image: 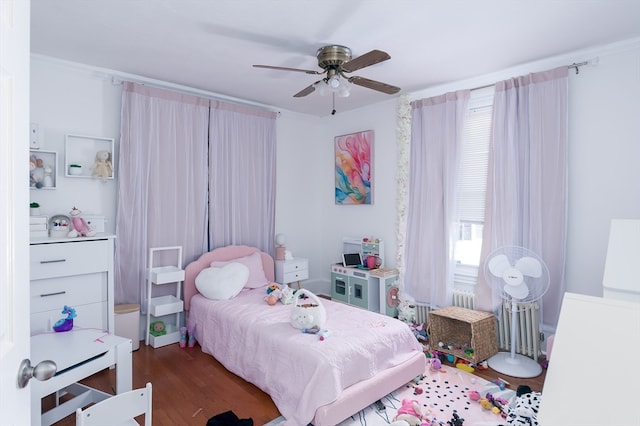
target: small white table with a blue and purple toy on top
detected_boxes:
[30,329,132,425]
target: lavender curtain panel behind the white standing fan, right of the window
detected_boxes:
[477,67,568,324]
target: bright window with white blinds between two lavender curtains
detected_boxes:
[454,87,493,285]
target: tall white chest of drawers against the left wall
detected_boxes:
[30,235,115,335]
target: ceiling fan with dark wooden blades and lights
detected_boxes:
[254,45,400,98]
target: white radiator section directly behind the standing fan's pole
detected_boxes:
[498,302,540,361]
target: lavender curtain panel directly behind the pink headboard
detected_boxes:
[209,101,277,254]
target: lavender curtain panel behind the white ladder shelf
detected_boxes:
[115,82,209,306]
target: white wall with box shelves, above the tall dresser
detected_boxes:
[30,56,121,233]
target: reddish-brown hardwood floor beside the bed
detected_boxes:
[48,342,545,426]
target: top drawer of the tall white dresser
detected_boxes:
[30,240,113,280]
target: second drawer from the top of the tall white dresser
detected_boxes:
[31,273,107,313]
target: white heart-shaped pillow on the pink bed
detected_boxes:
[196,262,249,300]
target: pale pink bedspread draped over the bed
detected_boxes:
[189,288,422,426]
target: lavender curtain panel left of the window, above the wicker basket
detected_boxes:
[402,90,470,306]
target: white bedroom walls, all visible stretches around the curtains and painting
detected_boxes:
[31,40,640,302]
